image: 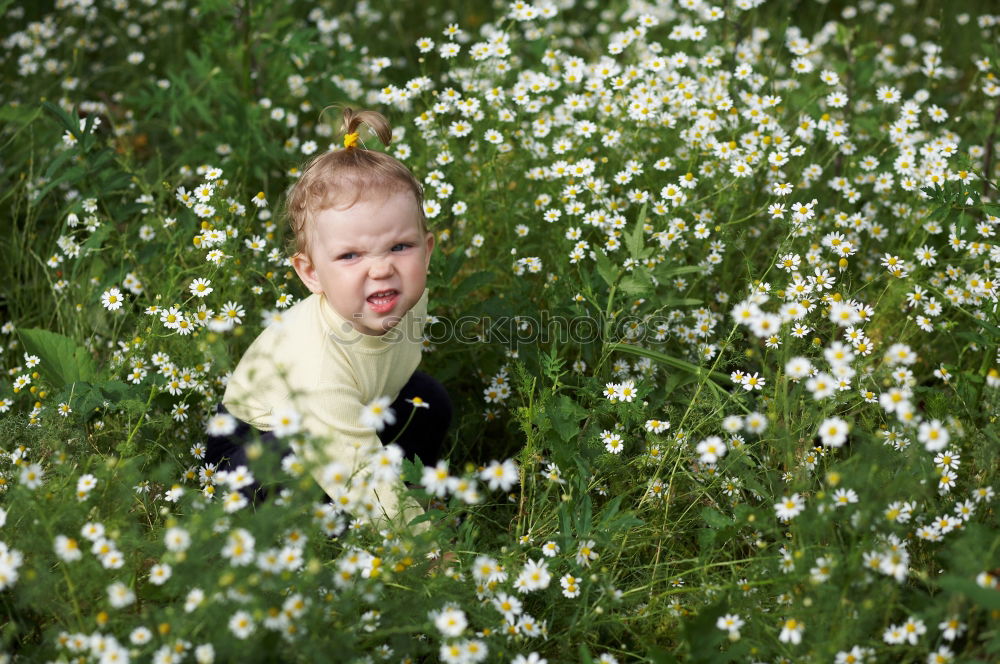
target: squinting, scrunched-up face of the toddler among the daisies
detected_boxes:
[292,191,434,335]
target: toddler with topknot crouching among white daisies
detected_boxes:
[206,108,451,526]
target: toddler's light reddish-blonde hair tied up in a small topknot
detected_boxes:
[285,107,427,253]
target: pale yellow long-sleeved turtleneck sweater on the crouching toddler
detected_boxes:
[223,290,427,530]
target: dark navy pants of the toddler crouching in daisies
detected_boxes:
[205,371,452,502]
